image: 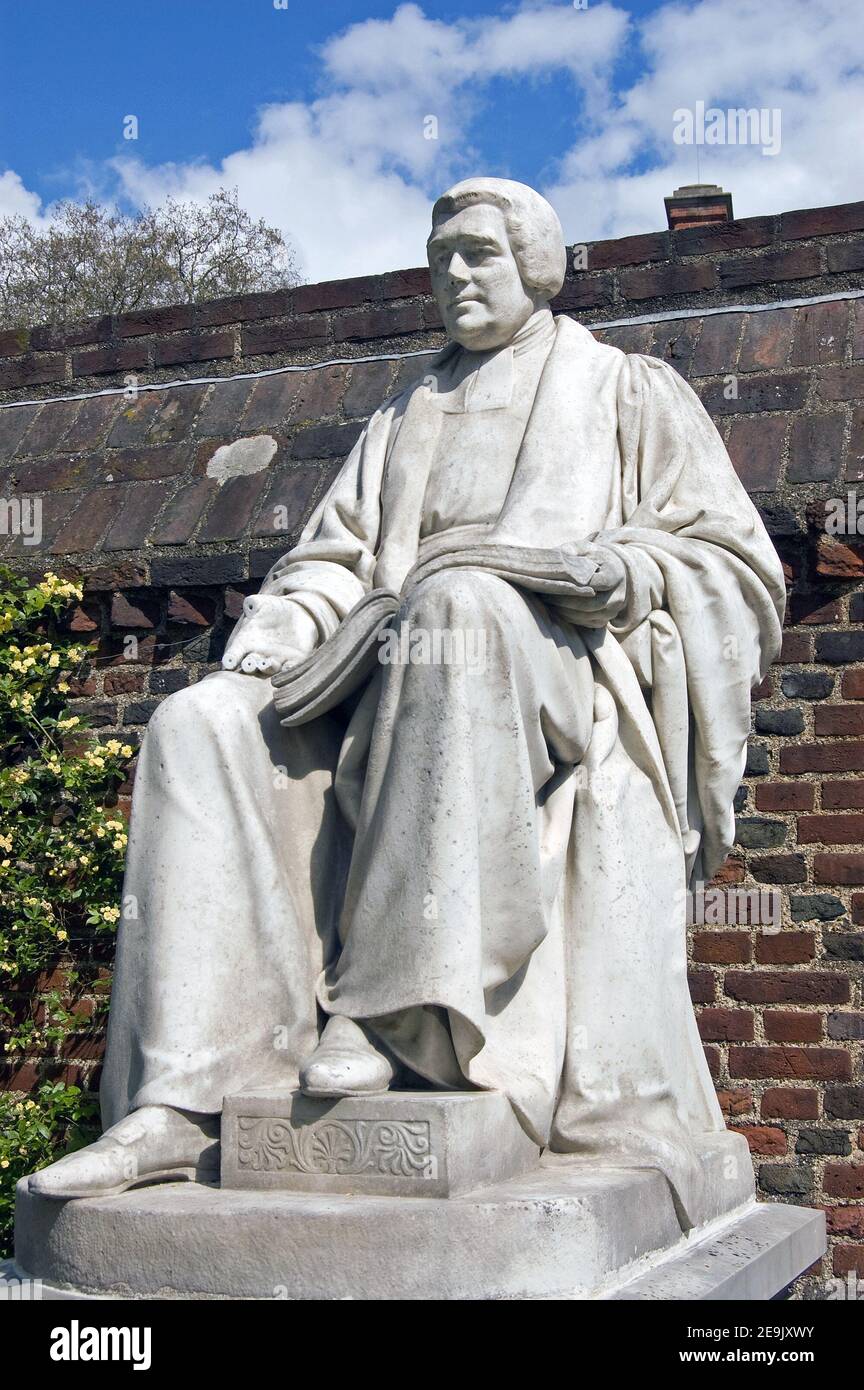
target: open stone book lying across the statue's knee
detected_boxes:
[272,538,597,727]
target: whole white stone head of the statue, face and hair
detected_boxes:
[426,178,567,352]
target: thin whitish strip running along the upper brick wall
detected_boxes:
[0,289,864,410]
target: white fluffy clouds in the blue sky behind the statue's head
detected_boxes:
[0,0,864,279]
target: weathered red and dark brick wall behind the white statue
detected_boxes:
[0,195,864,1277]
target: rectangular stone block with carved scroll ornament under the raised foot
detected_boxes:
[222,1090,539,1197]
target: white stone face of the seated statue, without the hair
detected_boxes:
[426,203,539,352]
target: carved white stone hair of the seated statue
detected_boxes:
[432,178,567,299]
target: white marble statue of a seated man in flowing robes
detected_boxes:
[31,178,783,1213]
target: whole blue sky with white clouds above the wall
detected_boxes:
[0,0,864,279]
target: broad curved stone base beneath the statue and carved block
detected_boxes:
[15,1165,825,1300]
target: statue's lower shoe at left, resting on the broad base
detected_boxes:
[28,1105,219,1201]
